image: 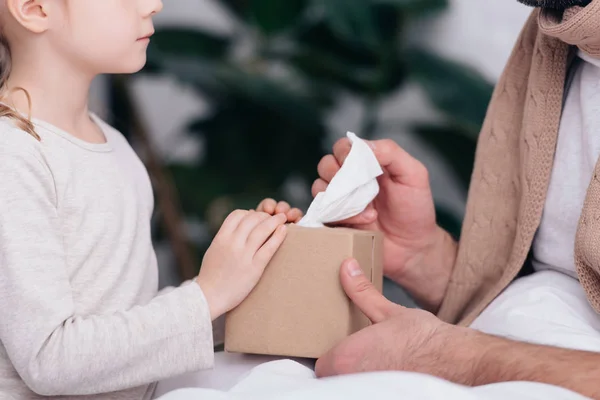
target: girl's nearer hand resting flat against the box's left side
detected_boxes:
[196,210,287,320]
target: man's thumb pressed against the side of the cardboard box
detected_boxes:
[340,258,402,323]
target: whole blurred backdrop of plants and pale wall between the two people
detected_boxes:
[92,0,530,340]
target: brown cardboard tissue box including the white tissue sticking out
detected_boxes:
[225,132,383,358]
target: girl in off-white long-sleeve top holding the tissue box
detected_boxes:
[0,0,300,399]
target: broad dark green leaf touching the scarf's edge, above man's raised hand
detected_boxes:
[406,49,493,135]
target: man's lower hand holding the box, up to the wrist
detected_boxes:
[316,260,459,377]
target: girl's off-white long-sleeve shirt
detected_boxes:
[0,116,214,400]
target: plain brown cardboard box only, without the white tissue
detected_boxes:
[225,225,383,358]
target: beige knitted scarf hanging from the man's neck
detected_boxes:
[439,0,600,325]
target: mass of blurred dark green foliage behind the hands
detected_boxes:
[108,0,492,272]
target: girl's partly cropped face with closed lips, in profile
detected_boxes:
[45,0,162,74]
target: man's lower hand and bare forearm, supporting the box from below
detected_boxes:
[316,260,600,399]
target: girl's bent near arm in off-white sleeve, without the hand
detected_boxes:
[0,149,214,395]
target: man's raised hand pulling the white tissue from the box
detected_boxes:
[312,138,457,311]
